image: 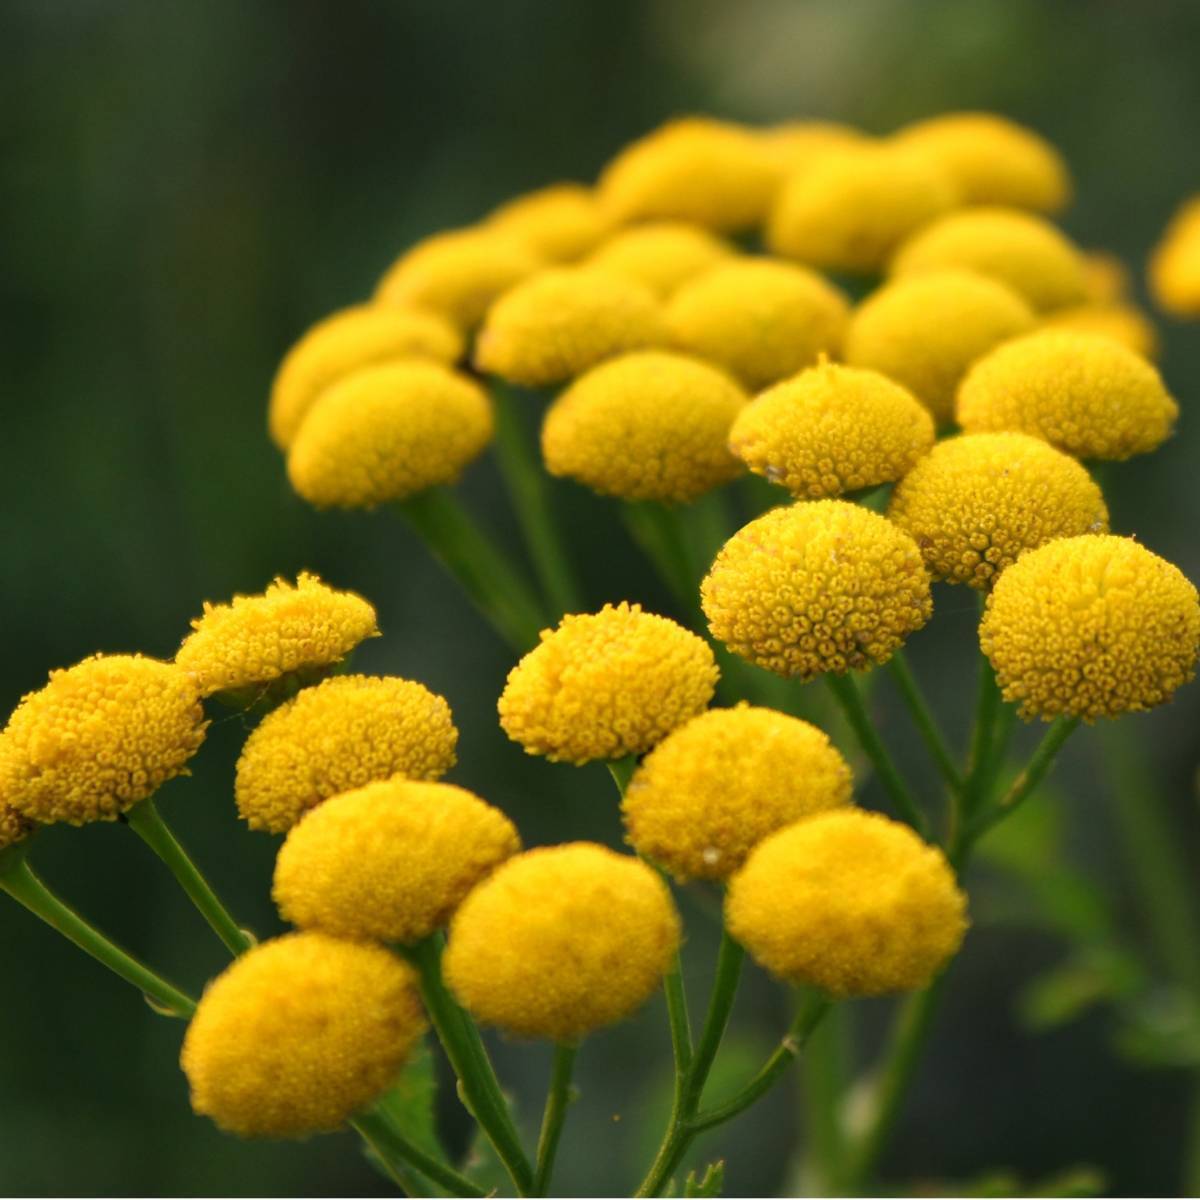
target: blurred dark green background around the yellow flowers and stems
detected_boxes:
[0,0,1200,1195]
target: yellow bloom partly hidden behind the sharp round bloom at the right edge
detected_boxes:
[888,433,1109,588]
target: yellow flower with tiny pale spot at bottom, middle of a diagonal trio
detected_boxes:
[622,703,851,881]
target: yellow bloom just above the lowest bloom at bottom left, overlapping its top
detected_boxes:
[272,779,521,944]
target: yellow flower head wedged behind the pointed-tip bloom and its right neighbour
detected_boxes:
[845,270,1034,425]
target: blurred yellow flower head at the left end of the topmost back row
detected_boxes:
[599,116,780,233]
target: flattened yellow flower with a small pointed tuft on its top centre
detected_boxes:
[730,362,934,499]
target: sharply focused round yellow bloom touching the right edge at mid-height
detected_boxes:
[979,534,1200,721]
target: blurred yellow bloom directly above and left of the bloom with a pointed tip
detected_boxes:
[666,258,850,390]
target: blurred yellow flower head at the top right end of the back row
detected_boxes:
[895,113,1072,212]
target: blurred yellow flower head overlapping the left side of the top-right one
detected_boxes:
[767,143,958,274]
